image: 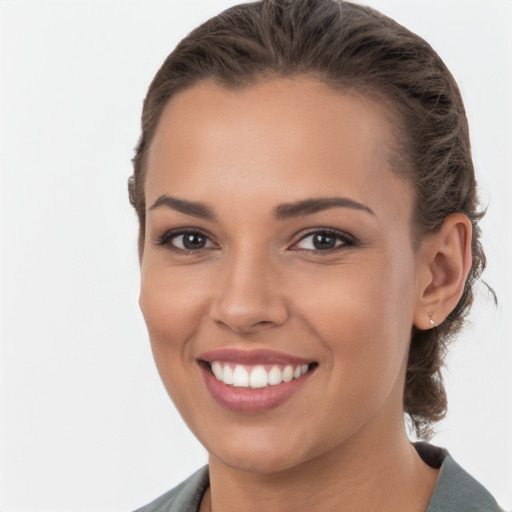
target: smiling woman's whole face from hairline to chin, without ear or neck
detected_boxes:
[140,78,426,472]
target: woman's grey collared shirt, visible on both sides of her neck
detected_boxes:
[136,443,503,512]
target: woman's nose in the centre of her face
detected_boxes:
[210,249,288,334]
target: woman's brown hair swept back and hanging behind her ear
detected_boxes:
[129,0,485,438]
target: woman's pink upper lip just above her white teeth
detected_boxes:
[198,348,314,365]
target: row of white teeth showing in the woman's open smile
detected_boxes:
[203,361,318,389]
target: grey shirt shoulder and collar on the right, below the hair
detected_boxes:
[415,443,502,512]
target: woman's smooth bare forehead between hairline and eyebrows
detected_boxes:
[146,78,408,220]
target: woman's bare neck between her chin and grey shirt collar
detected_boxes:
[205,428,438,512]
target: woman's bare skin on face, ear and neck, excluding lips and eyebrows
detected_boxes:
[140,78,471,512]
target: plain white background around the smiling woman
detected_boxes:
[0,0,512,512]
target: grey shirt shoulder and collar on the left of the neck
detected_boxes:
[135,466,209,512]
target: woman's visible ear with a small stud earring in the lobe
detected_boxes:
[414,213,472,329]
